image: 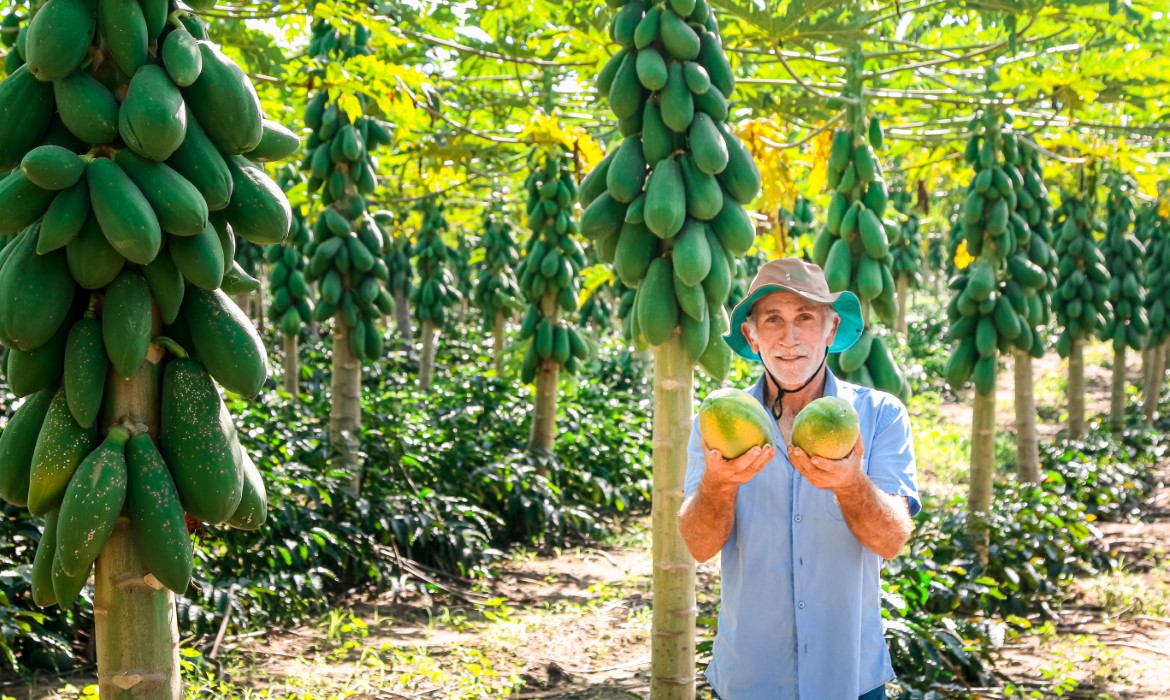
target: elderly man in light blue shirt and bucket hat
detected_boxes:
[679,259,920,700]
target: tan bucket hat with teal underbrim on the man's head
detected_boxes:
[723,258,866,362]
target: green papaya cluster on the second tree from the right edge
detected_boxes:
[1101,170,1150,351]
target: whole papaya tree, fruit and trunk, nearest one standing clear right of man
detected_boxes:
[944,105,1046,543]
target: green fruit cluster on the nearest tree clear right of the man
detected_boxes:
[944,110,1054,394]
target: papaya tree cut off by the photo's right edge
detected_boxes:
[1140,183,1170,420]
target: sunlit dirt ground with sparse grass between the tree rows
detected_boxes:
[9,344,1170,700]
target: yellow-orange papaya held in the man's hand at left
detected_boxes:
[697,388,776,459]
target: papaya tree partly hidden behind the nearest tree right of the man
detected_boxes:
[1007,146,1057,483]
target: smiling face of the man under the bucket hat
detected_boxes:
[741,290,841,389]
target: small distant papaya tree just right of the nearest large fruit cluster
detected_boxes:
[264,174,312,402]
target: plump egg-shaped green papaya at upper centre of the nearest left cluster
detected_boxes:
[118,64,187,160]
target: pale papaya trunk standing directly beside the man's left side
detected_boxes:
[651,336,697,700]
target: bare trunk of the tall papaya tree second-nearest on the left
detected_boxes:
[329,315,362,496]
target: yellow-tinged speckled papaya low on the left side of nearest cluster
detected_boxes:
[28,387,97,516]
